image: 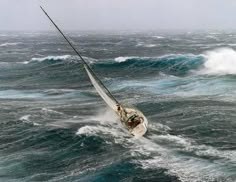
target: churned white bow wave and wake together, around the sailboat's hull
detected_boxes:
[76,118,235,182]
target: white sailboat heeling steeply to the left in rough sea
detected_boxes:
[40,6,148,138]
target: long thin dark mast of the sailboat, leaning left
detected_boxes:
[40,6,120,105]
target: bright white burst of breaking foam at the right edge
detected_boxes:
[200,48,236,75]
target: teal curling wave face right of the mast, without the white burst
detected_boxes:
[111,54,204,76]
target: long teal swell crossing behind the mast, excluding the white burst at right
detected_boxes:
[25,54,204,76]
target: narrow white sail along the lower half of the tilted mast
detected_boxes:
[84,65,117,111]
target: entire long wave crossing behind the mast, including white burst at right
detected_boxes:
[20,48,236,77]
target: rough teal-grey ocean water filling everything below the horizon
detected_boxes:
[0,31,236,182]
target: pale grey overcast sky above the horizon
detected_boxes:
[0,0,236,31]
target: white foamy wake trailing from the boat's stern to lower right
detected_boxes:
[131,135,235,182]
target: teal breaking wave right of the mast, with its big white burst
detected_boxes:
[115,48,236,76]
